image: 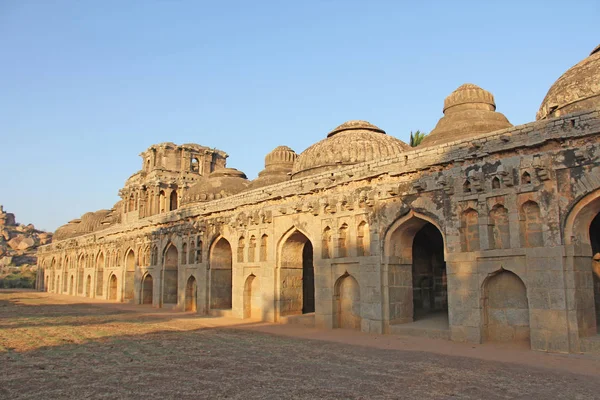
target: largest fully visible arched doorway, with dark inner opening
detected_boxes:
[386,212,448,329]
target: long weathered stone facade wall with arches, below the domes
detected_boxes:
[39,110,600,352]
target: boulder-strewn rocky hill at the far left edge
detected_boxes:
[0,206,52,288]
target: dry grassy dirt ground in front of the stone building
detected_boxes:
[0,291,600,400]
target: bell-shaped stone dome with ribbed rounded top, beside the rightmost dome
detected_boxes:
[420,83,512,146]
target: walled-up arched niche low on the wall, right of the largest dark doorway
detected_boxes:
[483,270,529,343]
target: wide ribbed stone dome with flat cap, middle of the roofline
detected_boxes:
[292,121,410,178]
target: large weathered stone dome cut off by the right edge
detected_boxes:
[536,46,600,120]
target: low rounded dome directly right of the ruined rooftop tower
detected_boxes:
[181,168,248,204]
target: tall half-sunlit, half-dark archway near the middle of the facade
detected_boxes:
[279,231,315,316]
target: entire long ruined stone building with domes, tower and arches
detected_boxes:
[38,48,600,352]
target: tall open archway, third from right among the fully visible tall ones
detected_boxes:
[209,237,233,309]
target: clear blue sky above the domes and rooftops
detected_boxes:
[0,0,600,230]
